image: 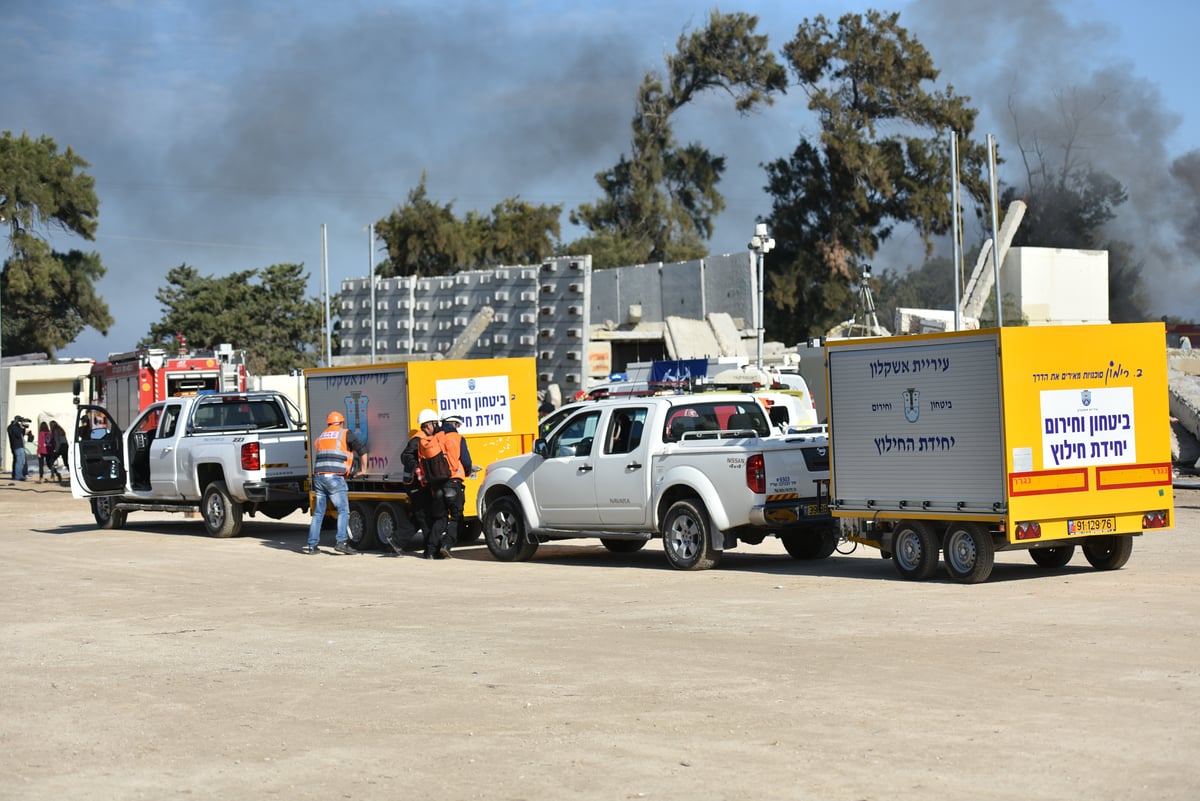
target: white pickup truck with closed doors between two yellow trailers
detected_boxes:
[476,393,839,570]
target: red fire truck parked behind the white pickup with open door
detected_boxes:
[86,344,247,429]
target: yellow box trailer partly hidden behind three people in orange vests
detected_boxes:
[304,357,538,549]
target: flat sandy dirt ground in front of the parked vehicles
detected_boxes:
[0,480,1200,801]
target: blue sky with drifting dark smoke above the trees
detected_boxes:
[7,0,1200,359]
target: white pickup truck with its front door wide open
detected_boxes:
[70,391,308,537]
